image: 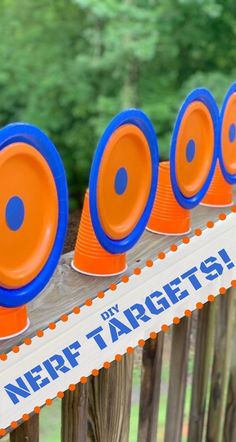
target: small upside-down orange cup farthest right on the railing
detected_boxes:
[201,163,233,207]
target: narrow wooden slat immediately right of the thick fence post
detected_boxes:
[138,333,164,442]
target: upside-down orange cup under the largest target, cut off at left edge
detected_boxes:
[0,305,29,340]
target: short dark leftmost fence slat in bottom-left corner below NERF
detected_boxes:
[10,414,39,442]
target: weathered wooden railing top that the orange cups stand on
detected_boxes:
[0,206,230,353]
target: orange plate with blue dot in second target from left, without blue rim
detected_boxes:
[97,124,152,239]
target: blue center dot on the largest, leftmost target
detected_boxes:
[6,196,25,231]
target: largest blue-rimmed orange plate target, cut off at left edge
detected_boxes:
[0,123,68,307]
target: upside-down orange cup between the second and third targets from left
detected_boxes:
[146,161,190,235]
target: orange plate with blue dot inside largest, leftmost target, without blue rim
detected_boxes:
[0,142,58,289]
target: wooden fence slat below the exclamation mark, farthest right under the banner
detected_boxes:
[206,289,234,442]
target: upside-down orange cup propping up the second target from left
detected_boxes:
[72,191,127,276]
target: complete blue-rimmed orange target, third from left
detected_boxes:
[170,89,219,209]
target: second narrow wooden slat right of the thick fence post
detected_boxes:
[165,317,191,442]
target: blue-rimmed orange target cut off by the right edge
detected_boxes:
[219,83,236,184]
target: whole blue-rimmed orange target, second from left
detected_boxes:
[89,109,158,253]
